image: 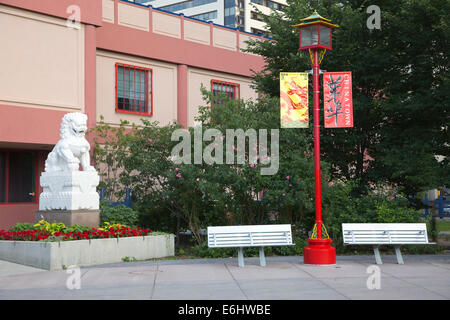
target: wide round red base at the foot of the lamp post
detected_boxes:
[303,239,336,265]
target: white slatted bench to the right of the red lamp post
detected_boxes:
[342,223,434,264]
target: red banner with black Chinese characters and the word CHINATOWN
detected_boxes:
[323,72,353,128]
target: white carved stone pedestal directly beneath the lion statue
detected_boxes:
[39,171,100,211]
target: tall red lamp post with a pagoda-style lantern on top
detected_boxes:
[293,11,338,265]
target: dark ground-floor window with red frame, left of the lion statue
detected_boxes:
[0,151,37,204]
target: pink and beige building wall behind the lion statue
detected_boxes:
[0,0,264,229]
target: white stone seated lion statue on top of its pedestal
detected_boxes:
[45,112,96,172]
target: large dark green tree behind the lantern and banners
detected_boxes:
[244,0,450,194]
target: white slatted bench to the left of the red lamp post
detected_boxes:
[208,224,294,267]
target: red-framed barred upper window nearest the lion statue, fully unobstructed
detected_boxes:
[116,63,153,116]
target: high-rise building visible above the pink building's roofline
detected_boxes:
[134,0,287,35]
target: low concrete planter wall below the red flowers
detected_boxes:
[0,234,175,270]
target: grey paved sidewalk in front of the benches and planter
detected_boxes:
[0,254,450,300]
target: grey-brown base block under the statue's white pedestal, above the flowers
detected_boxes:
[34,210,100,228]
